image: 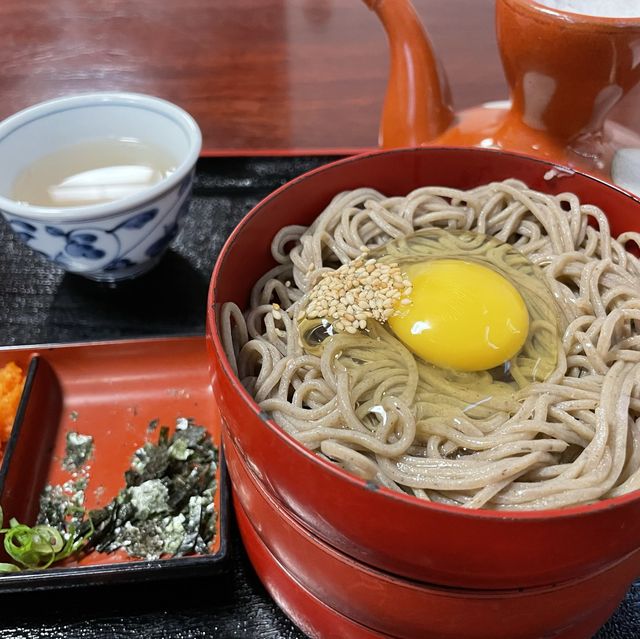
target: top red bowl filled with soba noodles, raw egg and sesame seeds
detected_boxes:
[207,147,640,600]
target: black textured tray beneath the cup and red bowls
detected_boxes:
[0,157,640,639]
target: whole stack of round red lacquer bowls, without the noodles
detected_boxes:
[207,148,640,639]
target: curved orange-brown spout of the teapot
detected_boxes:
[364,0,453,148]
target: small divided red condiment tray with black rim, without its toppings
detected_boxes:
[0,337,229,591]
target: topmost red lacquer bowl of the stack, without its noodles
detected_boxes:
[207,148,640,589]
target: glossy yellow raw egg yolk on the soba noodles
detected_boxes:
[389,259,529,371]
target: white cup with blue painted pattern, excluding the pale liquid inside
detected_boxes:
[0,93,202,282]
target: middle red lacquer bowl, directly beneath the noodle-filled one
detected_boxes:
[223,429,640,639]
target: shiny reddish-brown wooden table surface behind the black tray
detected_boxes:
[0,0,640,152]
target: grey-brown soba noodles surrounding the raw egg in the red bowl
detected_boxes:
[221,180,640,510]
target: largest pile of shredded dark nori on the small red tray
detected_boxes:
[80,418,218,559]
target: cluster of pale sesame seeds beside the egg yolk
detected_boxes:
[298,256,412,333]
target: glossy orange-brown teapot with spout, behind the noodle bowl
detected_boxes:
[365,0,640,194]
